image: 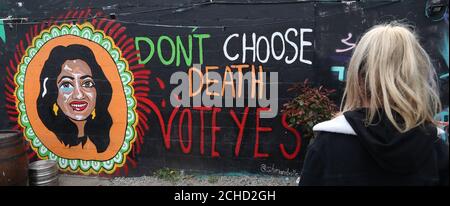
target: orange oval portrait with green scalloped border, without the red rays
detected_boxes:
[15,24,137,172]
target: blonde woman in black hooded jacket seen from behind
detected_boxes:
[300,23,449,186]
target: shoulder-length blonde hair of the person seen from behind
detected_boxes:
[341,22,441,133]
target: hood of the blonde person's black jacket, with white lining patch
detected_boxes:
[313,109,438,174]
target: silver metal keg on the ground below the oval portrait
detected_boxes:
[28,160,59,186]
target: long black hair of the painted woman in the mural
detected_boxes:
[37,44,112,153]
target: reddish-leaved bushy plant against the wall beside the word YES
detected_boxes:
[281,79,338,138]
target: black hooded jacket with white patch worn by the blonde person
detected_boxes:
[299,109,449,186]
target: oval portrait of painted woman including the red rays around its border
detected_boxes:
[5,10,155,174]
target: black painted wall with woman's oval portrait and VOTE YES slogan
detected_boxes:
[0,0,448,176]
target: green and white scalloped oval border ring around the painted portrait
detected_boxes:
[14,23,138,174]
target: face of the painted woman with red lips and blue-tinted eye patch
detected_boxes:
[56,59,97,121]
